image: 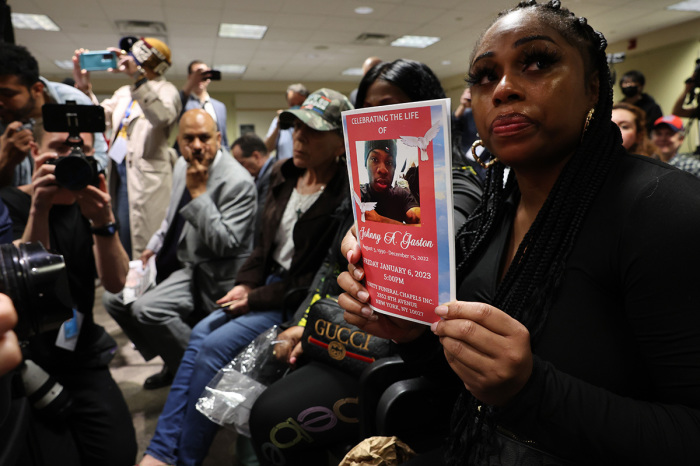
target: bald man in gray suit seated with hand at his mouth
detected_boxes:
[103,109,257,389]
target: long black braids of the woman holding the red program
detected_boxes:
[447,0,624,464]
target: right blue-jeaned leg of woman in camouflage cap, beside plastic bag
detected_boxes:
[177,311,282,466]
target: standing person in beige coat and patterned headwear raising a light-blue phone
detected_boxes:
[73,37,182,258]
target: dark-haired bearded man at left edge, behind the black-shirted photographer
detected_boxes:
[0,43,107,192]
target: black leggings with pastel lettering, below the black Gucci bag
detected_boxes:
[250,362,359,466]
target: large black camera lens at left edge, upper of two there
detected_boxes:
[0,243,73,339]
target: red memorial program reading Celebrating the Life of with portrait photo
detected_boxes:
[343,99,455,324]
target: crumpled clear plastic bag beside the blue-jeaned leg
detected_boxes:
[197,325,288,437]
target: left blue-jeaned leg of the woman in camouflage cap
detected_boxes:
[146,311,231,464]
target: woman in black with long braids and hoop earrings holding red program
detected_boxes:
[339,1,700,465]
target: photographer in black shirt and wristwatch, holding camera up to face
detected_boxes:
[0,124,137,466]
